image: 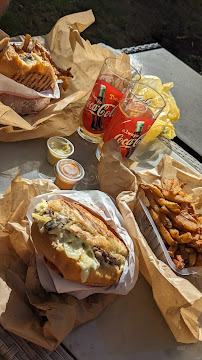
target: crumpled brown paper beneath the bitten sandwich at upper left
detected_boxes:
[0,10,129,142]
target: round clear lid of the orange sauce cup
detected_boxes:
[55,159,85,182]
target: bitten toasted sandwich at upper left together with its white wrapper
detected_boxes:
[0,34,72,114]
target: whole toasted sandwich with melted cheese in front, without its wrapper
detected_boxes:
[31,199,128,286]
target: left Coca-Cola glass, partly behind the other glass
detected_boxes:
[77,57,140,143]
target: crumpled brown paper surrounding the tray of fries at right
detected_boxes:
[98,143,202,343]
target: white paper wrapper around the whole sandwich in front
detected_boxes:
[27,190,138,299]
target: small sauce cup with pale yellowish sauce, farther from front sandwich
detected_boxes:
[47,136,74,165]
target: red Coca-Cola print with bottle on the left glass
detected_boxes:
[83,79,123,134]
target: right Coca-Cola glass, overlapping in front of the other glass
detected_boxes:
[96,81,166,160]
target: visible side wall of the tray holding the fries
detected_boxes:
[134,193,202,276]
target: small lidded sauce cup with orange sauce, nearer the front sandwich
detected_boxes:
[55,159,85,190]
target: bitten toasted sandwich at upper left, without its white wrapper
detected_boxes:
[0,34,72,92]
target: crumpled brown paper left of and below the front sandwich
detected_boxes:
[0,175,116,350]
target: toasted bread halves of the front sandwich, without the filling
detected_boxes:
[31,200,128,286]
